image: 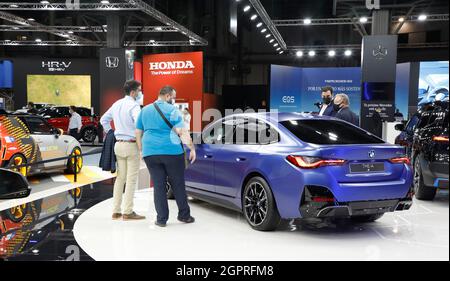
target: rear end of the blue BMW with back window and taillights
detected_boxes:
[282,119,413,218]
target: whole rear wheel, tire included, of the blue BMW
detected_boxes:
[242,177,281,231]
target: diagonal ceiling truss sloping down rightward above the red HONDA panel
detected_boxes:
[125,0,208,46]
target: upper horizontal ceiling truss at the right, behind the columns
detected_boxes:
[273,14,449,26]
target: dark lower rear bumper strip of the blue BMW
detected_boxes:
[300,199,412,218]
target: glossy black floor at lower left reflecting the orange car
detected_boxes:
[0,181,112,261]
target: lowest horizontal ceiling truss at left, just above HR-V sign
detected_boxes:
[0,40,203,47]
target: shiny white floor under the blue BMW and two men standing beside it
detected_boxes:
[74,190,449,261]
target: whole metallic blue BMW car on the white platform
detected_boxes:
[181,113,413,231]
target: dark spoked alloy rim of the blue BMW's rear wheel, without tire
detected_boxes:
[244,182,269,226]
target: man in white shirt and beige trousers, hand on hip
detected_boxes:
[100,80,145,221]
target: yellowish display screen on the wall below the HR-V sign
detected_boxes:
[27,75,91,108]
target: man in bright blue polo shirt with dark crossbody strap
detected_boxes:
[136,86,196,227]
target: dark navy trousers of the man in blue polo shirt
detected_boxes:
[144,154,191,223]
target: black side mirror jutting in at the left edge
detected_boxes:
[0,169,31,200]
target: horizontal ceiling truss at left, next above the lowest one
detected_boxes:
[0,25,178,33]
